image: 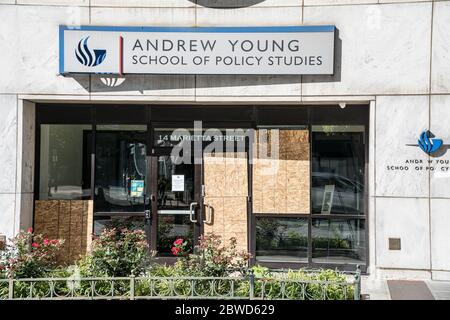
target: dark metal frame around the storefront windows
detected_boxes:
[33,103,372,272]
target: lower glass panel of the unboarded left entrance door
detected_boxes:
[156,214,194,255]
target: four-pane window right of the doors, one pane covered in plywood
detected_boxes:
[253,125,366,264]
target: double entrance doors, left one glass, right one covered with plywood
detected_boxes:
[151,123,248,257]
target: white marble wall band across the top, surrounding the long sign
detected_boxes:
[0,0,440,101]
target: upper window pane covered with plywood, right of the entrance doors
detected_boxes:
[253,127,311,214]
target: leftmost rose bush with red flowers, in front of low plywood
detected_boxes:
[0,228,64,278]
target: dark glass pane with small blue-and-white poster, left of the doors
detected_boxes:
[94,125,150,240]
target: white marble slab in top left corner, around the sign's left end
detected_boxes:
[0,5,89,95]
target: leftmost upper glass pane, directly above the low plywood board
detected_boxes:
[39,124,92,200]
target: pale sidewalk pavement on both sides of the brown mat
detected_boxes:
[361,276,450,300]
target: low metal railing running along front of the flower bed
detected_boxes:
[0,269,361,300]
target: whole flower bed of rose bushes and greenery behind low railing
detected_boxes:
[0,228,360,300]
